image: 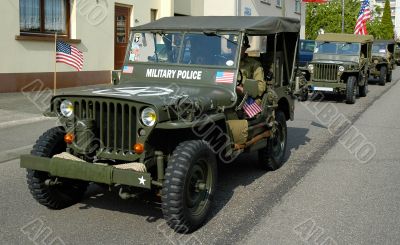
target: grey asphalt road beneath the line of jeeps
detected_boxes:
[0,72,400,244]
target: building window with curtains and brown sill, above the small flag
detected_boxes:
[19,0,69,36]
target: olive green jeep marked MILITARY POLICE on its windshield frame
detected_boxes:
[21,17,300,232]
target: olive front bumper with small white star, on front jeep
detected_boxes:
[20,155,152,189]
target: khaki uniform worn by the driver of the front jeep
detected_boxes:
[239,56,266,96]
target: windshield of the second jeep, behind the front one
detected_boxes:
[314,42,360,56]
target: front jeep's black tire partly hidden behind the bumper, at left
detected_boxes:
[27,127,87,209]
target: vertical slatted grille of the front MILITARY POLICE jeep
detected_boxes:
[73,99,136,153]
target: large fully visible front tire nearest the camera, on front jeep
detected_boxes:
[161,140,217,233]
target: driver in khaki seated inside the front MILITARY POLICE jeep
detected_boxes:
[237,36,266,105]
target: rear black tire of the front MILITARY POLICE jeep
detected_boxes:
[258,111,287,171]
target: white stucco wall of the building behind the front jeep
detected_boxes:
[0,0,174,73]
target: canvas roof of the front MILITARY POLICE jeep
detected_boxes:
[133,16,300,35]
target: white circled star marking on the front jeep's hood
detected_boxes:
[92,87,174,97]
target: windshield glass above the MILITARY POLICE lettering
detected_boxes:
[127,32,238,67]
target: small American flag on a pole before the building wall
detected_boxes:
[56,41,83,71]
